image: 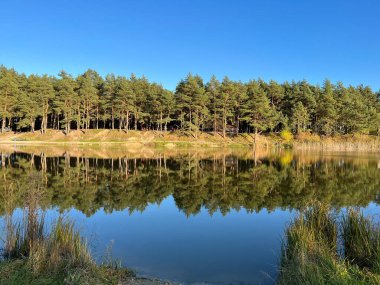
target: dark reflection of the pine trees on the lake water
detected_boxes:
[0,154,380,215]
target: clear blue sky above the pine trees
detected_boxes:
[0,0,380,90]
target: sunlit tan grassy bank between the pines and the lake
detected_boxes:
[0,130,380,152]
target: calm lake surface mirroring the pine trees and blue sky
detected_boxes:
[0,146,380,285]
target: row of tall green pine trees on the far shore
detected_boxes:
[0,66,380,138]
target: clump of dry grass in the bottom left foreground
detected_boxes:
[0,212,133,284]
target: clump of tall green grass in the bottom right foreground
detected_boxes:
[278,205,380,284]
